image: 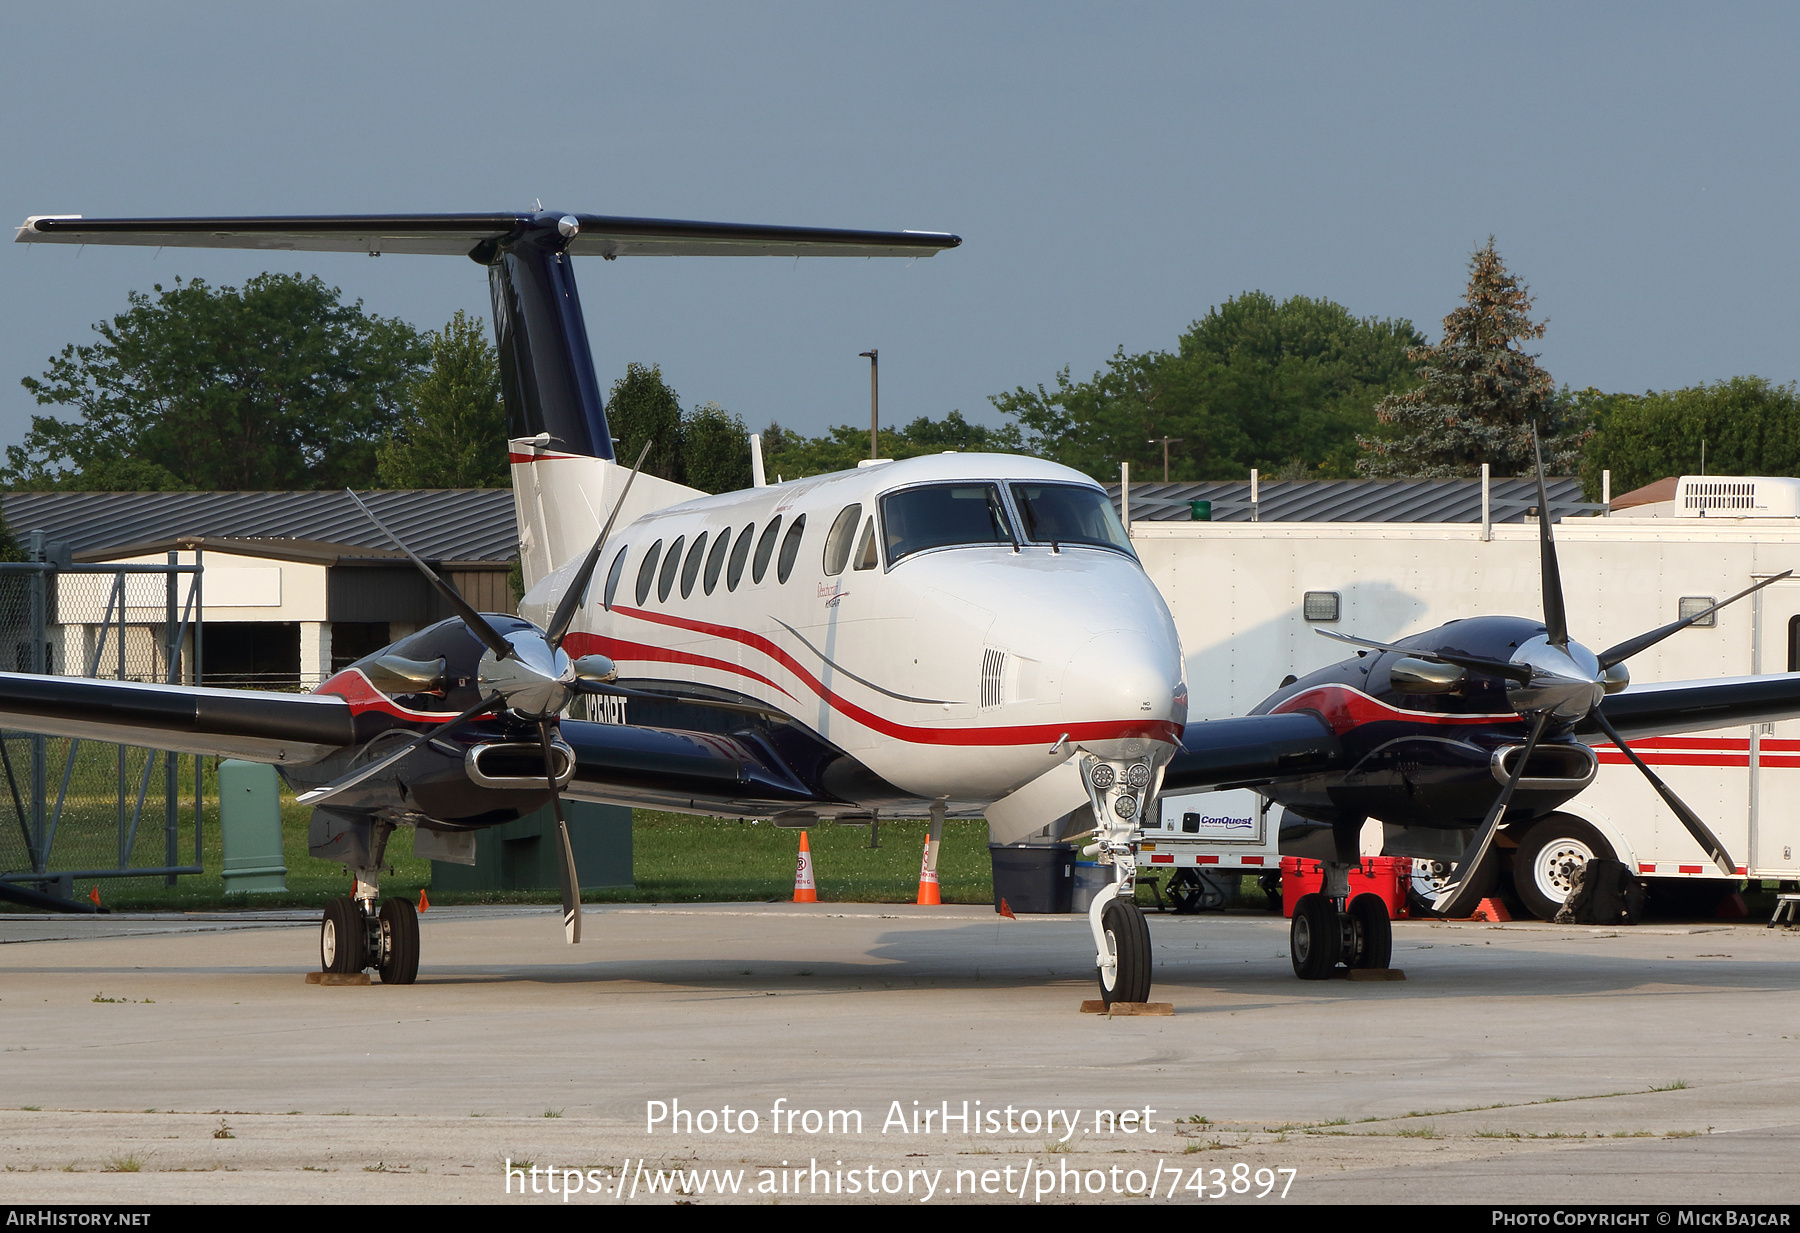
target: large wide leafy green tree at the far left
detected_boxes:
[4,274,427,490]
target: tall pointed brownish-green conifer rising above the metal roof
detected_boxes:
[1357,236,1586,475]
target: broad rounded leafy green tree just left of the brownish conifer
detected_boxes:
[992,292,1424,479]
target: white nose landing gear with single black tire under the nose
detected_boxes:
[1082,754,1163,1006]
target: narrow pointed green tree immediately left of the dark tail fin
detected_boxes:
[378,308,511,488]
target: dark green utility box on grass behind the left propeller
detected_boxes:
[432,801,632,891]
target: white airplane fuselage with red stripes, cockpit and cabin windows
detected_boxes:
[524,454,1186,812]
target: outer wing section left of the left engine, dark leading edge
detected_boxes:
[0,671,356,765]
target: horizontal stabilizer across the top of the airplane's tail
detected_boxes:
[14,212,963,261]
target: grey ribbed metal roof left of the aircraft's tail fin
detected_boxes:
[0,488,518,562]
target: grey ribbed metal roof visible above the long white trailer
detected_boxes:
[1107,475,1602,522]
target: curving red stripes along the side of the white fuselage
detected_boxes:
[567,607,1181,745]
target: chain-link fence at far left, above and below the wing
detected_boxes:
[0,535,202,896]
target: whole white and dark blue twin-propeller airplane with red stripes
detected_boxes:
[10,212,1800,1003]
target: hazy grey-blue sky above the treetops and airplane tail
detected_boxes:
[0,2,1800,453]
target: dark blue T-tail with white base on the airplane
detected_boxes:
[16,211,961,589]
